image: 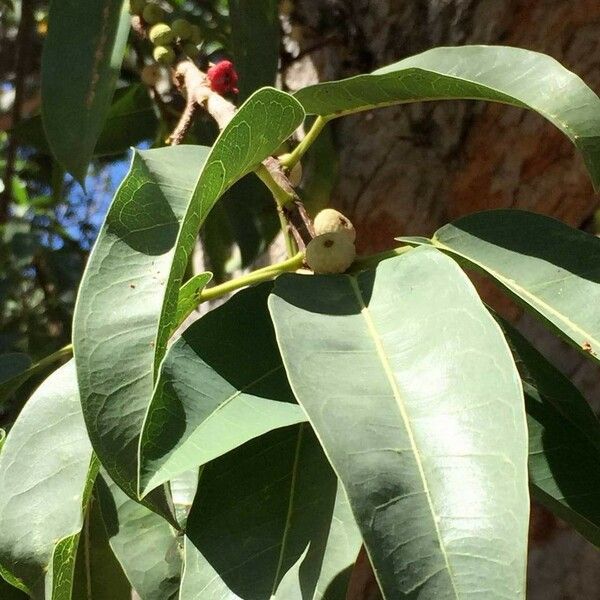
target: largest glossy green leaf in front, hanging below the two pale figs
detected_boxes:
[269,248,529,600]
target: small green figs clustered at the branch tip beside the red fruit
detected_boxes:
[129,0,202,66]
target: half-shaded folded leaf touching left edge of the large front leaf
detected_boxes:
[140,283,306,493]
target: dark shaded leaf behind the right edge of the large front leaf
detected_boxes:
[500,320,600,546]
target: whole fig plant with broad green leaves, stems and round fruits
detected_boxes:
[0,0,600,600]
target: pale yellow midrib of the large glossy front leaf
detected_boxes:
[349,277,460,600]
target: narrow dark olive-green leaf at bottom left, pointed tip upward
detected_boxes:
[73,498,131,600]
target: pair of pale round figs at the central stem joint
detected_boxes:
[304,208,356,273]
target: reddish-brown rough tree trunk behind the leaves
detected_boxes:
[284,0,600,600]
